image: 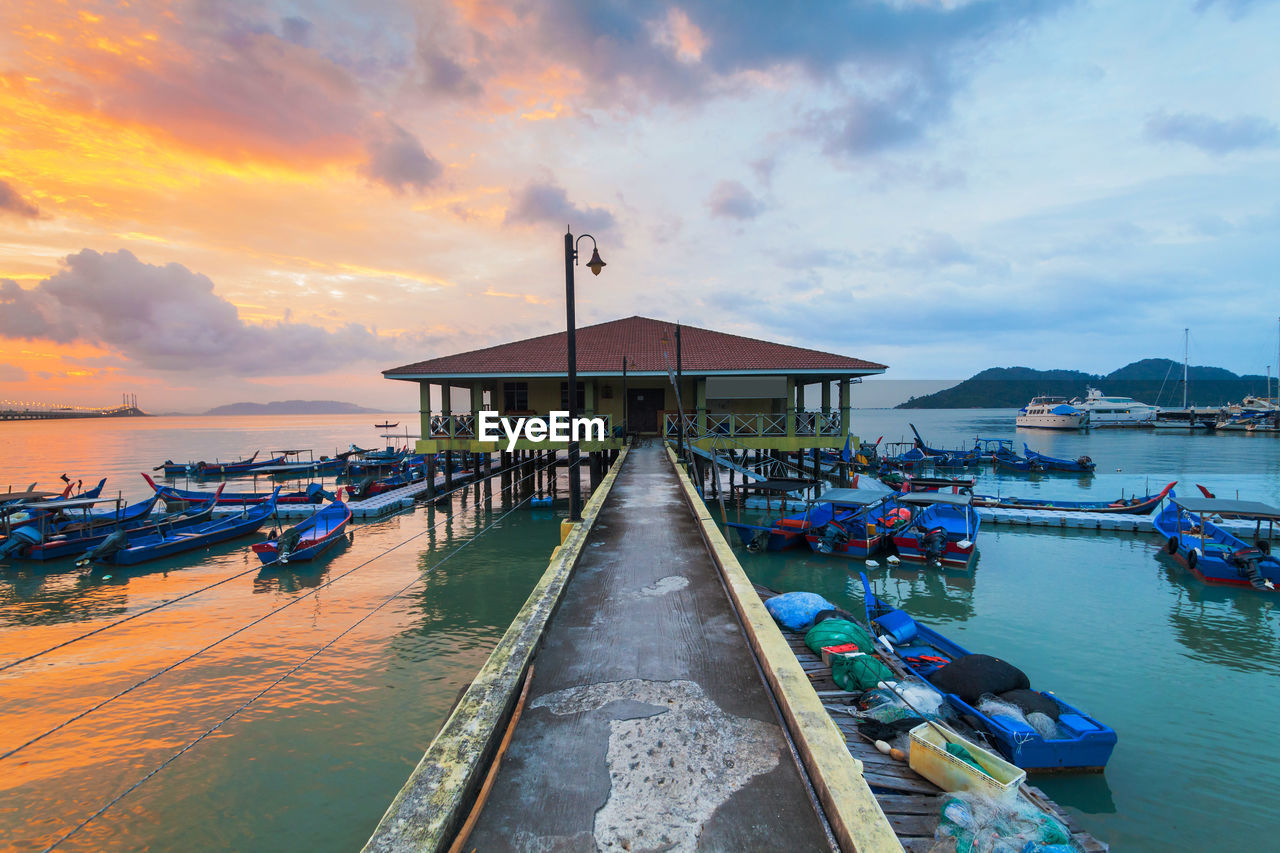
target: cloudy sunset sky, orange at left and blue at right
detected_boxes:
[0,0,1280,411]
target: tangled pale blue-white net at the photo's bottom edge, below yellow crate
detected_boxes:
[934,792,1080,853]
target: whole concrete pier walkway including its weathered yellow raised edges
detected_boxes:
[365,446,902,853]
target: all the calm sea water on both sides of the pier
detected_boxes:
[0,410,1280,850]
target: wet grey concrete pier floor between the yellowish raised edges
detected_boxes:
[462,447,835,850]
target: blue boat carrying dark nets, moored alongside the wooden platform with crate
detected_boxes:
[861,575,1116,771]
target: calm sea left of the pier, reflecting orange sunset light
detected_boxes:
[0,415,564,852]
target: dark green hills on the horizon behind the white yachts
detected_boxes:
[897,359,1267,409]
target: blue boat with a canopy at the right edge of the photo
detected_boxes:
[1152,496,1280,592]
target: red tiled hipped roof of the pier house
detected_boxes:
[383,316,884,379]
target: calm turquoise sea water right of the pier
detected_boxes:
[714,410,1280,850]
